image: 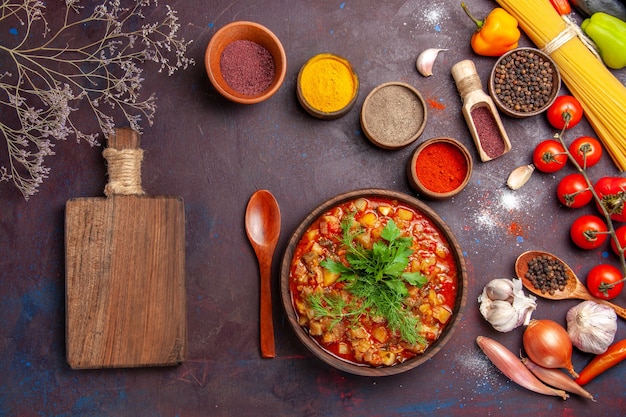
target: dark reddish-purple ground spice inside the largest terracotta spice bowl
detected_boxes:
[220,40,276,96]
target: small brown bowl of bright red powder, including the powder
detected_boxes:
[407,137,473,200]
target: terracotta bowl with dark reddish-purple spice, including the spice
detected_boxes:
[204,21,287,104]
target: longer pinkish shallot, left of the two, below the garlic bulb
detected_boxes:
[476,336,569,400]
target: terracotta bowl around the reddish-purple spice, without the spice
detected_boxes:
[204,21,287,104]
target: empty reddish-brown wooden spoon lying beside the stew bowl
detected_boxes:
[246,190,280,358]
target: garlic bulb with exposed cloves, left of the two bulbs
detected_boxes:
[478,278,537,333]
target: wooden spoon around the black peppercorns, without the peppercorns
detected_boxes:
[515,250,626,318]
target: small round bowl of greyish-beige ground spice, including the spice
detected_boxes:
[361,82,427,149]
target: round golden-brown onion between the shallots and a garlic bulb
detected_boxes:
[523,320,578,378]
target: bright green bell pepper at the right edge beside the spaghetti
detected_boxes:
[580,12,626,69]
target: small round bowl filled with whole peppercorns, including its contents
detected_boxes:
[489,48,561,118]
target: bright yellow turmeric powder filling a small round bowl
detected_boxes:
[298,54,358,113]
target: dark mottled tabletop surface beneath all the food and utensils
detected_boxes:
[0,0,626,417]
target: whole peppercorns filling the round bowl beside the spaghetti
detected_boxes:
[493,49,556,113]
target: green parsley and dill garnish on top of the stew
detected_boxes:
[316,215,427,343]
